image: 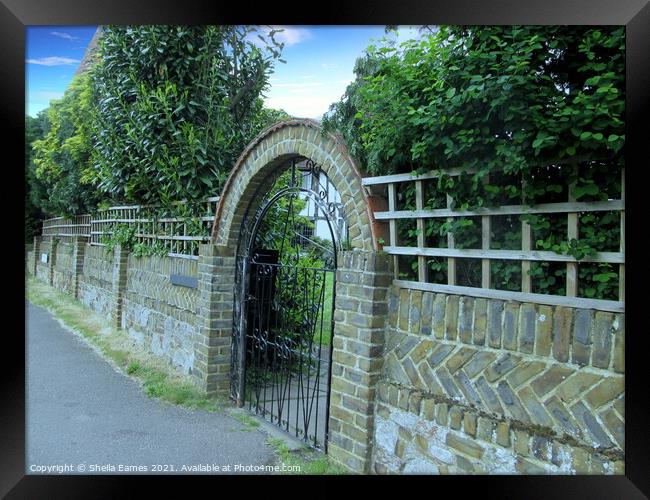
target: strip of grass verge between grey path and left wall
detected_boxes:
[26,278,229,412]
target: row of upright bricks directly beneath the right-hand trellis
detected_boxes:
[387,289,625,373]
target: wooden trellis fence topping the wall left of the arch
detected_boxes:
[43,196,219,258]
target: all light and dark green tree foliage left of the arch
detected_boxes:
[25,26,288,249]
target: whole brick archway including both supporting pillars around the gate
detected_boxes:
[192,119,393,472]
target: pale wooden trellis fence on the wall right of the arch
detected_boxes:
[363,164,625,312]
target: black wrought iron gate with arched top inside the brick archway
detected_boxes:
[231,160,347,450]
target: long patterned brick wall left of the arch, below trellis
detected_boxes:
[27,238,202,376]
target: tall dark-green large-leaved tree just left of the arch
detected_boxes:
[93,26,282,209]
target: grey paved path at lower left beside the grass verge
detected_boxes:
[25,302,276,474]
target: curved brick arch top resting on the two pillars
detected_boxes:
[212,119,381,253]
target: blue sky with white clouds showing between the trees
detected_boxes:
[25,26,417,118]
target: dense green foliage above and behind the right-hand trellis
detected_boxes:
[324,26,625,298]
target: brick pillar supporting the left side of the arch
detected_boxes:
[192,244,235,395]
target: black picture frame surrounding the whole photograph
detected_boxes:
[0,0,650,500]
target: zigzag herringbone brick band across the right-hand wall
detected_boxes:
[384,335,624,448]
